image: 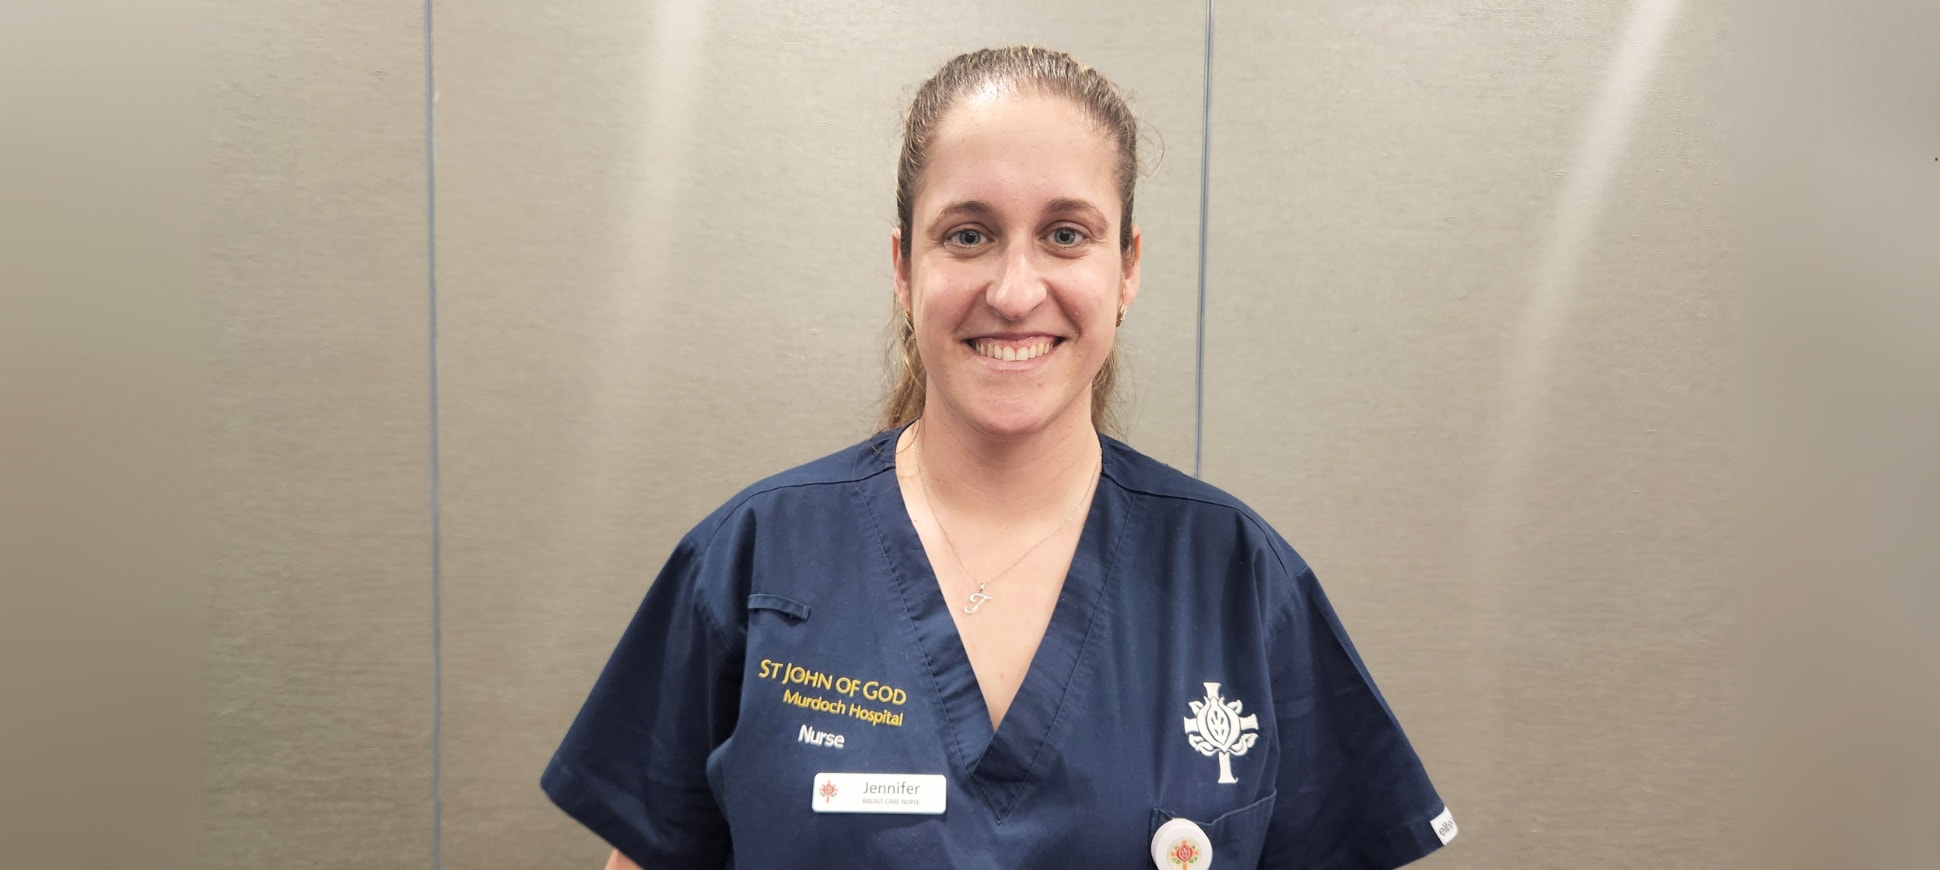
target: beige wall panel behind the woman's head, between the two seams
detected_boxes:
[435,2,1203,870]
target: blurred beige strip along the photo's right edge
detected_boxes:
[1742,0,1940,870]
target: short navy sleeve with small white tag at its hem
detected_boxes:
[1261,557,1453,870]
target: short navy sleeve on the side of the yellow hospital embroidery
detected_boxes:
[539,540,743,868]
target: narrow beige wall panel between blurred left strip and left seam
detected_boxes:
[204,2,433,870]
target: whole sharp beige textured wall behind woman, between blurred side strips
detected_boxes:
[204,0,1740,870]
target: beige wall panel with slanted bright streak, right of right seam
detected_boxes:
[1205,0,1740,868]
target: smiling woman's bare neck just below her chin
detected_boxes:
[896,402,1100,520]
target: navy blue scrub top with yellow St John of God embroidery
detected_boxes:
[541,431,1449,870]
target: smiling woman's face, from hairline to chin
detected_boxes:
[890,93,1141,439]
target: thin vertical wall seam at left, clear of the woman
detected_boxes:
[425,0,444,870]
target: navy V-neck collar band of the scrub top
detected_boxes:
[857,429,1133,821]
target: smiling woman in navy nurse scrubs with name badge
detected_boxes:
[541,49,1455,870]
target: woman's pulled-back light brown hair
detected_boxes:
[881,45,1139,435]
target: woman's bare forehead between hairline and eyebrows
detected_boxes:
[916,89,1117,214]
